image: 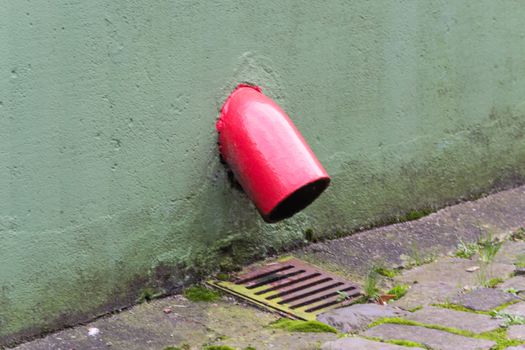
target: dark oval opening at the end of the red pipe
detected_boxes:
[264,178,330,222]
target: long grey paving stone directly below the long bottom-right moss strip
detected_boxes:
[363,324,496,350]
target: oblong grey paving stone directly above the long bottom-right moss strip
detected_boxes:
[405,306,502,333]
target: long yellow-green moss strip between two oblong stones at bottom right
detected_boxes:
[368,317,525,350]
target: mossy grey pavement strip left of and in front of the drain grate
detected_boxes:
[13,295,337,350]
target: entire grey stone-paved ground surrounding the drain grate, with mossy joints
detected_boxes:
[7,187,525,350]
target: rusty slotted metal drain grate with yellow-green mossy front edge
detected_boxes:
[208,258,362,320]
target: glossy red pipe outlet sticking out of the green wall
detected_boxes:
[217,84,330,222]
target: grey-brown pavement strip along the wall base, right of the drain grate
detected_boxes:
[293,186,525,276]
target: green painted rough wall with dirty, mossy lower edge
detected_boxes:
[0,0,525,344]
